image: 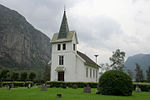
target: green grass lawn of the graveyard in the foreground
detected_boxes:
[0,87,150,100]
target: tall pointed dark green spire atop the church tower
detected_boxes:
[58,7,69,39]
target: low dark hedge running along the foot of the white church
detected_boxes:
[46,81,98,88]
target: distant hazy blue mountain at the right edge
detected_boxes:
[125,54,150,74]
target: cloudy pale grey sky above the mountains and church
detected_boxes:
[0,0,150,64]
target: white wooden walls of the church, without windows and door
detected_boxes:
[51,32,96,82]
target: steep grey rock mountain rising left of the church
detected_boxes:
[0,5,51,70]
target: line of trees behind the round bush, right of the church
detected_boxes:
[100,49,150,82]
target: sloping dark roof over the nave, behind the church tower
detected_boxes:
[77,51,100,68]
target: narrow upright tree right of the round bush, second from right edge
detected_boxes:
[135,64,144,82]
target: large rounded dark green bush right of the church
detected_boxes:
[99,70,133,96]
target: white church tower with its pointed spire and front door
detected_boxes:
[51,10,78,81]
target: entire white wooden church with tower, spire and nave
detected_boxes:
[51,10,99,82]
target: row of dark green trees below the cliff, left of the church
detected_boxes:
[0,64,50,82]
